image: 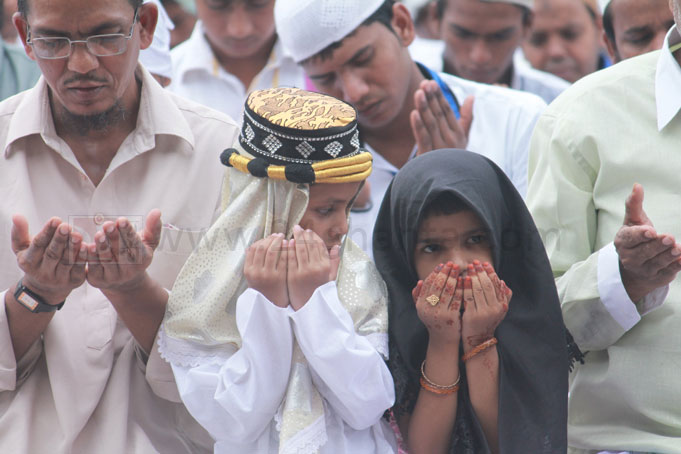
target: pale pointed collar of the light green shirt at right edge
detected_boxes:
[655,26,681,131]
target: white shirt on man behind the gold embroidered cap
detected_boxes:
[168,21,305,123]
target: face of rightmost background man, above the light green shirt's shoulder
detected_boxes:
[602,0,674,63]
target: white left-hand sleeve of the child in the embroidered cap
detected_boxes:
[173,289,293,444]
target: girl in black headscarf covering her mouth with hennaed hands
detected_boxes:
[374,150,579,454]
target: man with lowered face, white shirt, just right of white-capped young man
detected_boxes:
[428,0,568,103]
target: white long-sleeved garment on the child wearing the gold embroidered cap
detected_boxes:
[167,282,397,454]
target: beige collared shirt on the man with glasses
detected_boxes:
[0,67,238,454]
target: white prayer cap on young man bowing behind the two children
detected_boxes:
[274,0,384,62]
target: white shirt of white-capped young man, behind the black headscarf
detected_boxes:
[348,74,546,257]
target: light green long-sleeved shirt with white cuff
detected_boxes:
[527,31,681,453]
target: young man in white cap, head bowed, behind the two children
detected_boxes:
[274,0,545,253]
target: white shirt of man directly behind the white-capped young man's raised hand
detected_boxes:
[409,39,570,104]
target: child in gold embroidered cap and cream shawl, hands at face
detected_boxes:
[159,88,396,454]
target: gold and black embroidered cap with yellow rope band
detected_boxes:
[221,88,372,183]
